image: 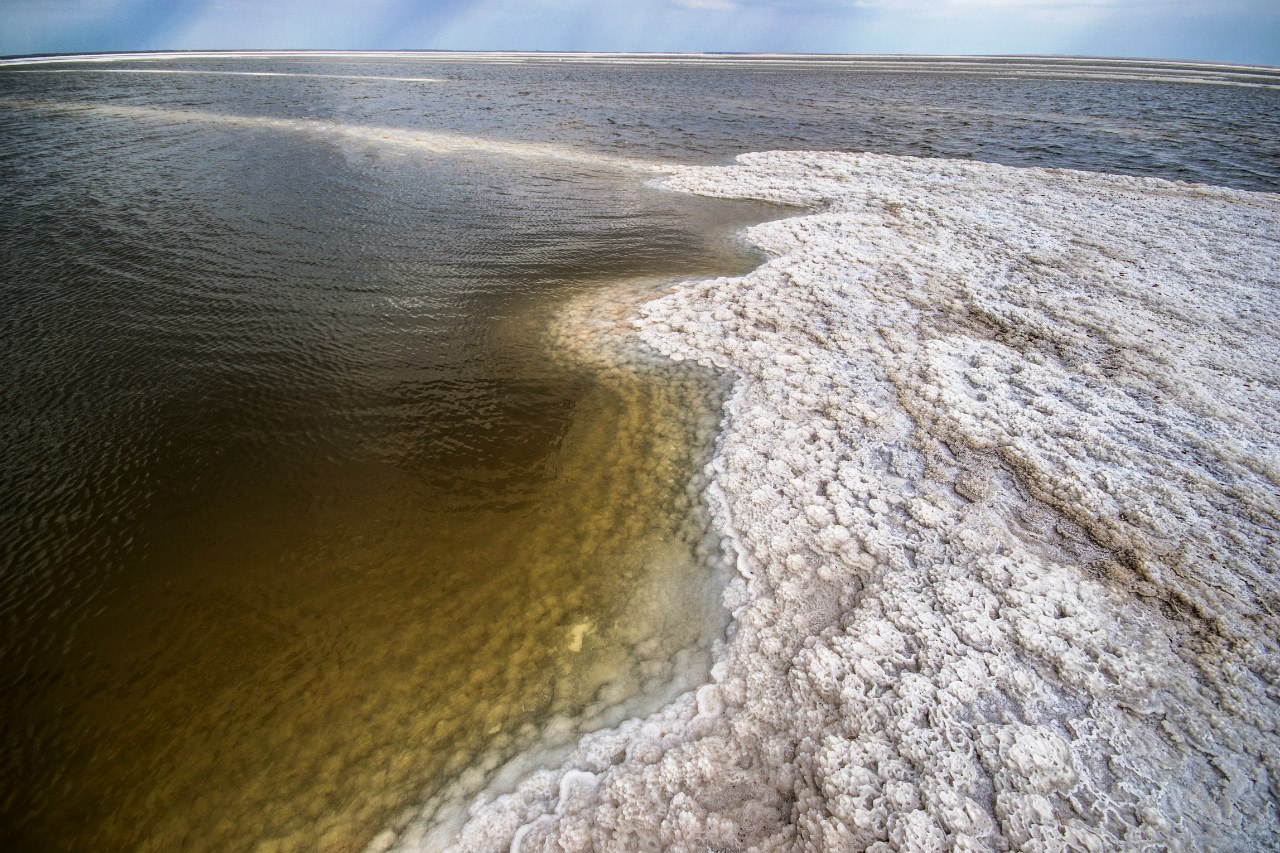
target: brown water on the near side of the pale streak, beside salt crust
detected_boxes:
[0,81,760,850]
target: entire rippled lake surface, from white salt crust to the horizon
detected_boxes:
[0,55,1280,850]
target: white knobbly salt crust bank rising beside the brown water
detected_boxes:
[379,152,1280,853]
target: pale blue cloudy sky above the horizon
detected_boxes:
[0,0,1280,65]
